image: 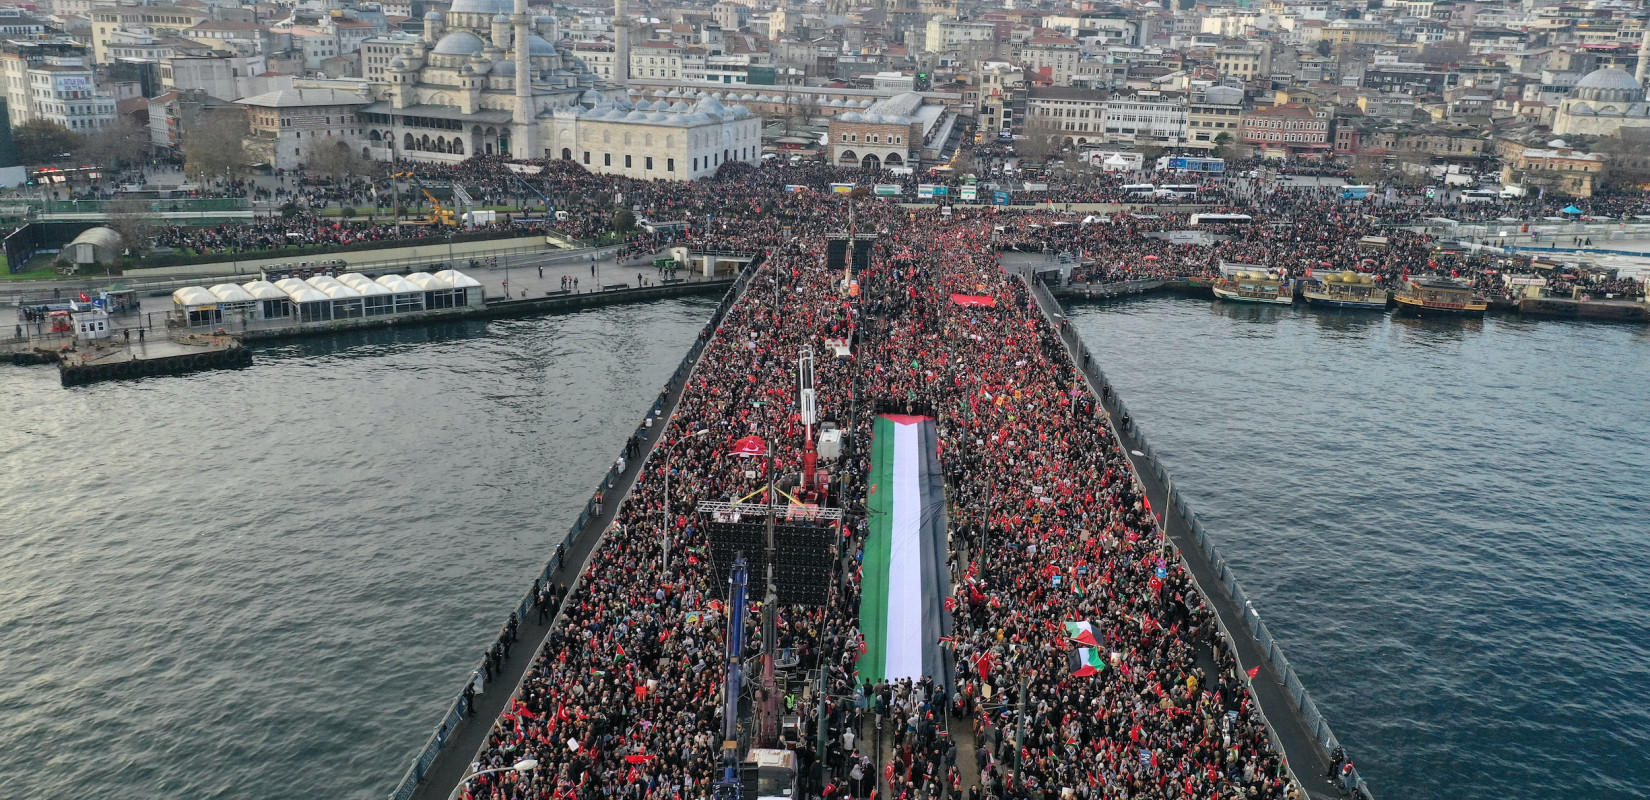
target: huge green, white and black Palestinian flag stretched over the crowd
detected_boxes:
[858,414,952,686]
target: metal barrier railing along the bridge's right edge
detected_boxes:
[1020,274,1373,800]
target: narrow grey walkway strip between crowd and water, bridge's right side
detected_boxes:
[1020,263,1370,800]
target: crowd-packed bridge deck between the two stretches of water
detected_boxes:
[402,208,1366,798]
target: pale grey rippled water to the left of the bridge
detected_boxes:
[0,300,713,800]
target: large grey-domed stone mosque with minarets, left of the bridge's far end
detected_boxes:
[355,0,762,180]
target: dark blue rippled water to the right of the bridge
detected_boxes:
[1069,297,1650,800]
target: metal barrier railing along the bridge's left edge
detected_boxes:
[389,254,764,800]
